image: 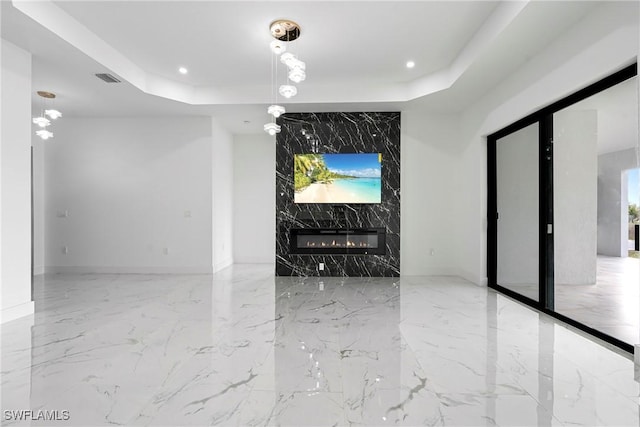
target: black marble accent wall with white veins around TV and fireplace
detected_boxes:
[276,112,400,277]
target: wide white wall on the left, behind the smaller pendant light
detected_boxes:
[44,117,212,273]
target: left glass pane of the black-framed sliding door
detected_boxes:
[496,123,540,301]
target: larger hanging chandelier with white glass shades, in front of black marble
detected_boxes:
[264,19,307,135]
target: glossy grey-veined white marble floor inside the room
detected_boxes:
[1,265,640,426]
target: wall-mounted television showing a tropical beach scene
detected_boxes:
[293,153,382,203]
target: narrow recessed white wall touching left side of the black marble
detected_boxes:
[233,134,276,263]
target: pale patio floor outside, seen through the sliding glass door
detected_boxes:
[505,255,640,344]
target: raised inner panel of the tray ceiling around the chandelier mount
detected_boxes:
[55,1,497,87]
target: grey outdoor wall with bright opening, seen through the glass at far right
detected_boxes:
[598,148,638,257]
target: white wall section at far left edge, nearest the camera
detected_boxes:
[0,40,34,323]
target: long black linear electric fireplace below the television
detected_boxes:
[289,228,386,255]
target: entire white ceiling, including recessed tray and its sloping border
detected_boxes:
[0,0,632,133]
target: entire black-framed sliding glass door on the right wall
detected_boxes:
[487,64,640,351]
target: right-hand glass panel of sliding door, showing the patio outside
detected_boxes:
[553,77,640,344]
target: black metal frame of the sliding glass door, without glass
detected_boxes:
[487,63,638,353]
